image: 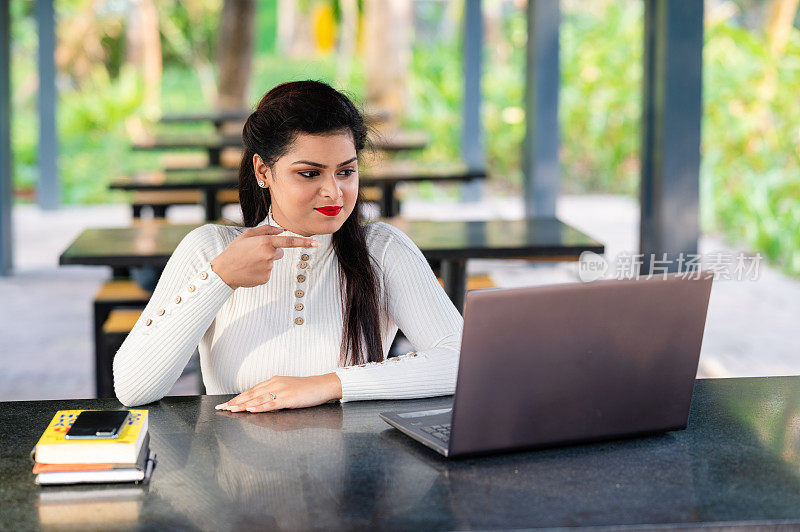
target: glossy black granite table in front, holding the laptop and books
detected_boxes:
[0,377,800,531]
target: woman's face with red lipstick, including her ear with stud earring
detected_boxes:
[253,130,358,236]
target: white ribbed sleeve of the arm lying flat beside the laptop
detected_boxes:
[336,224,464,402]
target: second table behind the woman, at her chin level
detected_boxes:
[109,161,486,221]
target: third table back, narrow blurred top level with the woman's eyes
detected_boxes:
[131,130,430,166]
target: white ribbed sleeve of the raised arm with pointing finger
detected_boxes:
[113,225,234,406]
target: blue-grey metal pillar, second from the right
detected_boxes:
[522,0,561,217]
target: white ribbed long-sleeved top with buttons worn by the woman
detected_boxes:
[114,208,463,406]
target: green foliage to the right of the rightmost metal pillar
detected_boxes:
[700,17,800,275]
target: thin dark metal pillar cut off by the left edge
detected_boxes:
[0,2,13,276]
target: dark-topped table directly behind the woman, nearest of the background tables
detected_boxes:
[59,217,604,311]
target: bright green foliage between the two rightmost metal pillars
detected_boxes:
[559,2,644,194]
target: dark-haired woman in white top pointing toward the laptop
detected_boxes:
[114,81,463,412]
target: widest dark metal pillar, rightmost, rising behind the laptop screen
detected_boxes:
[639,0,703,274]
